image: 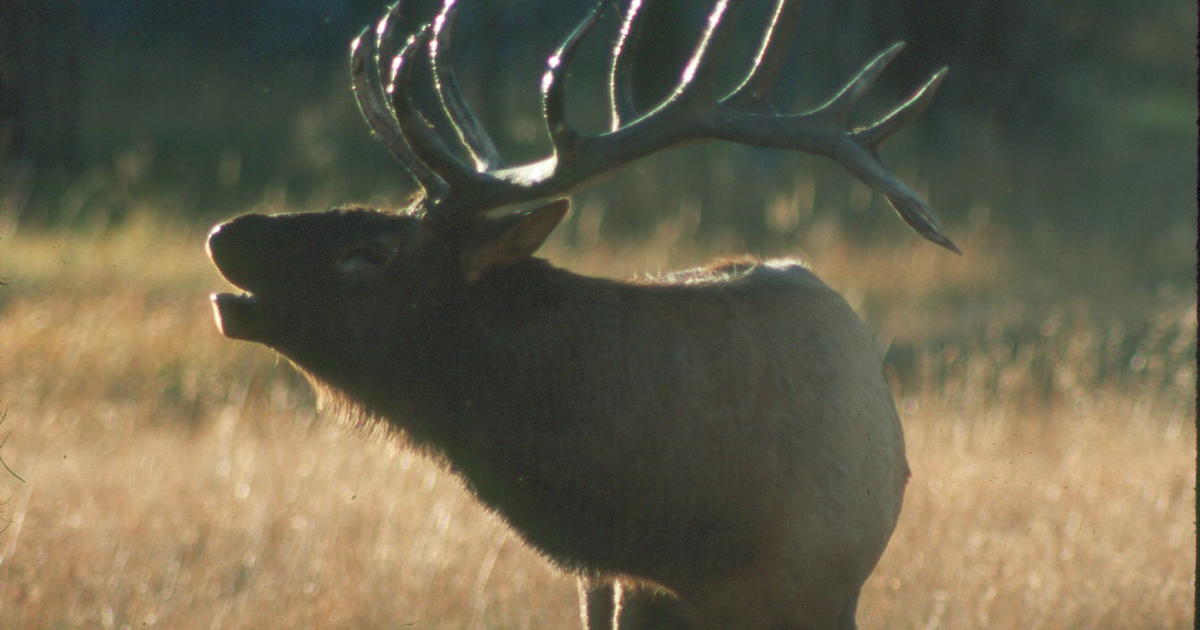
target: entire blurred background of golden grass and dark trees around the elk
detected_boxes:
[0,0,1198,629]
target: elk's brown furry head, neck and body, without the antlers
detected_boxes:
[209,205,908,629]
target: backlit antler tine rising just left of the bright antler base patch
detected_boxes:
[430,0,504,170]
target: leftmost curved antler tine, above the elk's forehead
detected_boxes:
[350,5,445,194]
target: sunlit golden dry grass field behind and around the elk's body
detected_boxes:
[0,207,1196,629]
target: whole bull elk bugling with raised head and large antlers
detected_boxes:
[208,0,958,630]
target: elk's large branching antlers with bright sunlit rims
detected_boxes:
[350,0,961,253]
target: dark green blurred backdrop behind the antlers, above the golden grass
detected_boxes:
[0,0,1196,243]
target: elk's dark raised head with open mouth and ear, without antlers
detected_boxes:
[208,200,566,395]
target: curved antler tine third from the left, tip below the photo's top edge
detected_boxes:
[386,24,474,188]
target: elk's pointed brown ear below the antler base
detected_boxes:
[462,199,569,283]
